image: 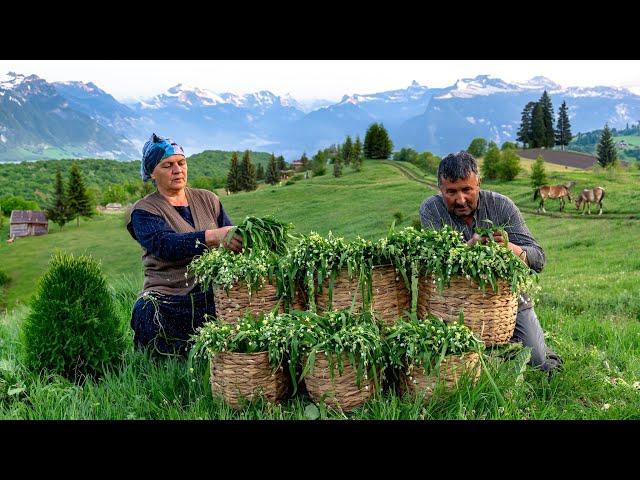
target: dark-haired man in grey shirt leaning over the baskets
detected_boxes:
[420,152,562,372]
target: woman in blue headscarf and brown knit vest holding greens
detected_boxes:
[127,133,242,354]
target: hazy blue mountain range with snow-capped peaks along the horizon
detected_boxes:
[0,72,640,162]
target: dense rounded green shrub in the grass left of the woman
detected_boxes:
[21,253,126,380]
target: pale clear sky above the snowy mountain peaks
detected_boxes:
[0,60,640,101]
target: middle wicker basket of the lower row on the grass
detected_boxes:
[303,353,375,412]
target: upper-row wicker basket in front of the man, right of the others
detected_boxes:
[418,276,518,346]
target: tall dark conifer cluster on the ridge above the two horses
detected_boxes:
[517,90,572,150]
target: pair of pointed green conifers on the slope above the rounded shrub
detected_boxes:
[46,163,95,229]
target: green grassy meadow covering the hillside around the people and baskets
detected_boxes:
[0,161,640,419]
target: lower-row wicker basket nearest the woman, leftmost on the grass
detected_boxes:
[210,352,289,409]
